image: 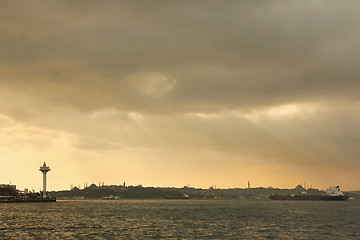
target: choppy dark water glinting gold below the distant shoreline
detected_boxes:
[0,200,360,239]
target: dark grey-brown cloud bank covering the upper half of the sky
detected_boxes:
[0,1,360,112]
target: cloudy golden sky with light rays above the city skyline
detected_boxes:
[0,0,360,191]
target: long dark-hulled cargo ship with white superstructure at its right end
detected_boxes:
[270,186,349,201]
